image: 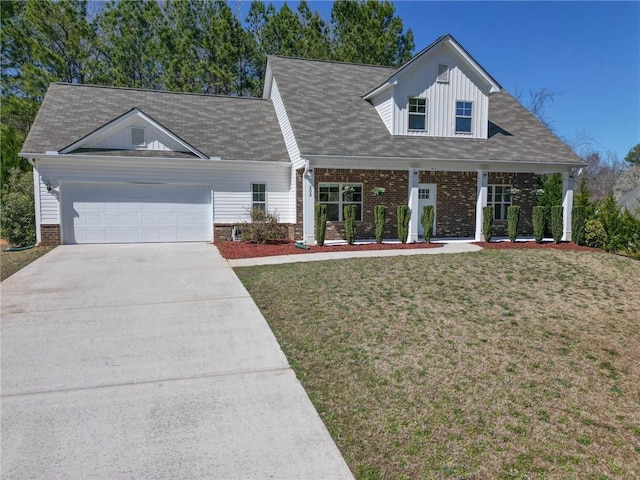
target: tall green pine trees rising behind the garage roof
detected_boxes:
[0,0,414,178]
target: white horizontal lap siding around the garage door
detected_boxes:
[38,158,295,224]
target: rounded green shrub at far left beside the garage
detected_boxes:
[0,168,36,247]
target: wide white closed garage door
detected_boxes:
[61,183,213,243]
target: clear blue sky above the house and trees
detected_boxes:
[238,0,640,160]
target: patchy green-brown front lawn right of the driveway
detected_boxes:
[236,250,640,480]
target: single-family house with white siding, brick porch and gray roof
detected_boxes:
[21,35,583,248]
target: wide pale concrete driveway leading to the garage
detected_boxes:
[0,244,353,480]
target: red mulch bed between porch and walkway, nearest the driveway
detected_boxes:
[216,242,443,260]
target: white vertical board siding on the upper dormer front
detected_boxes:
[393,48,489,138]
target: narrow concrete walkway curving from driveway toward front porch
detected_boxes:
[227,242,482,267]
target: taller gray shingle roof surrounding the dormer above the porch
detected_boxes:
[269,56,582,165]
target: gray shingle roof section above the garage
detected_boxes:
[22,83,289,162]
